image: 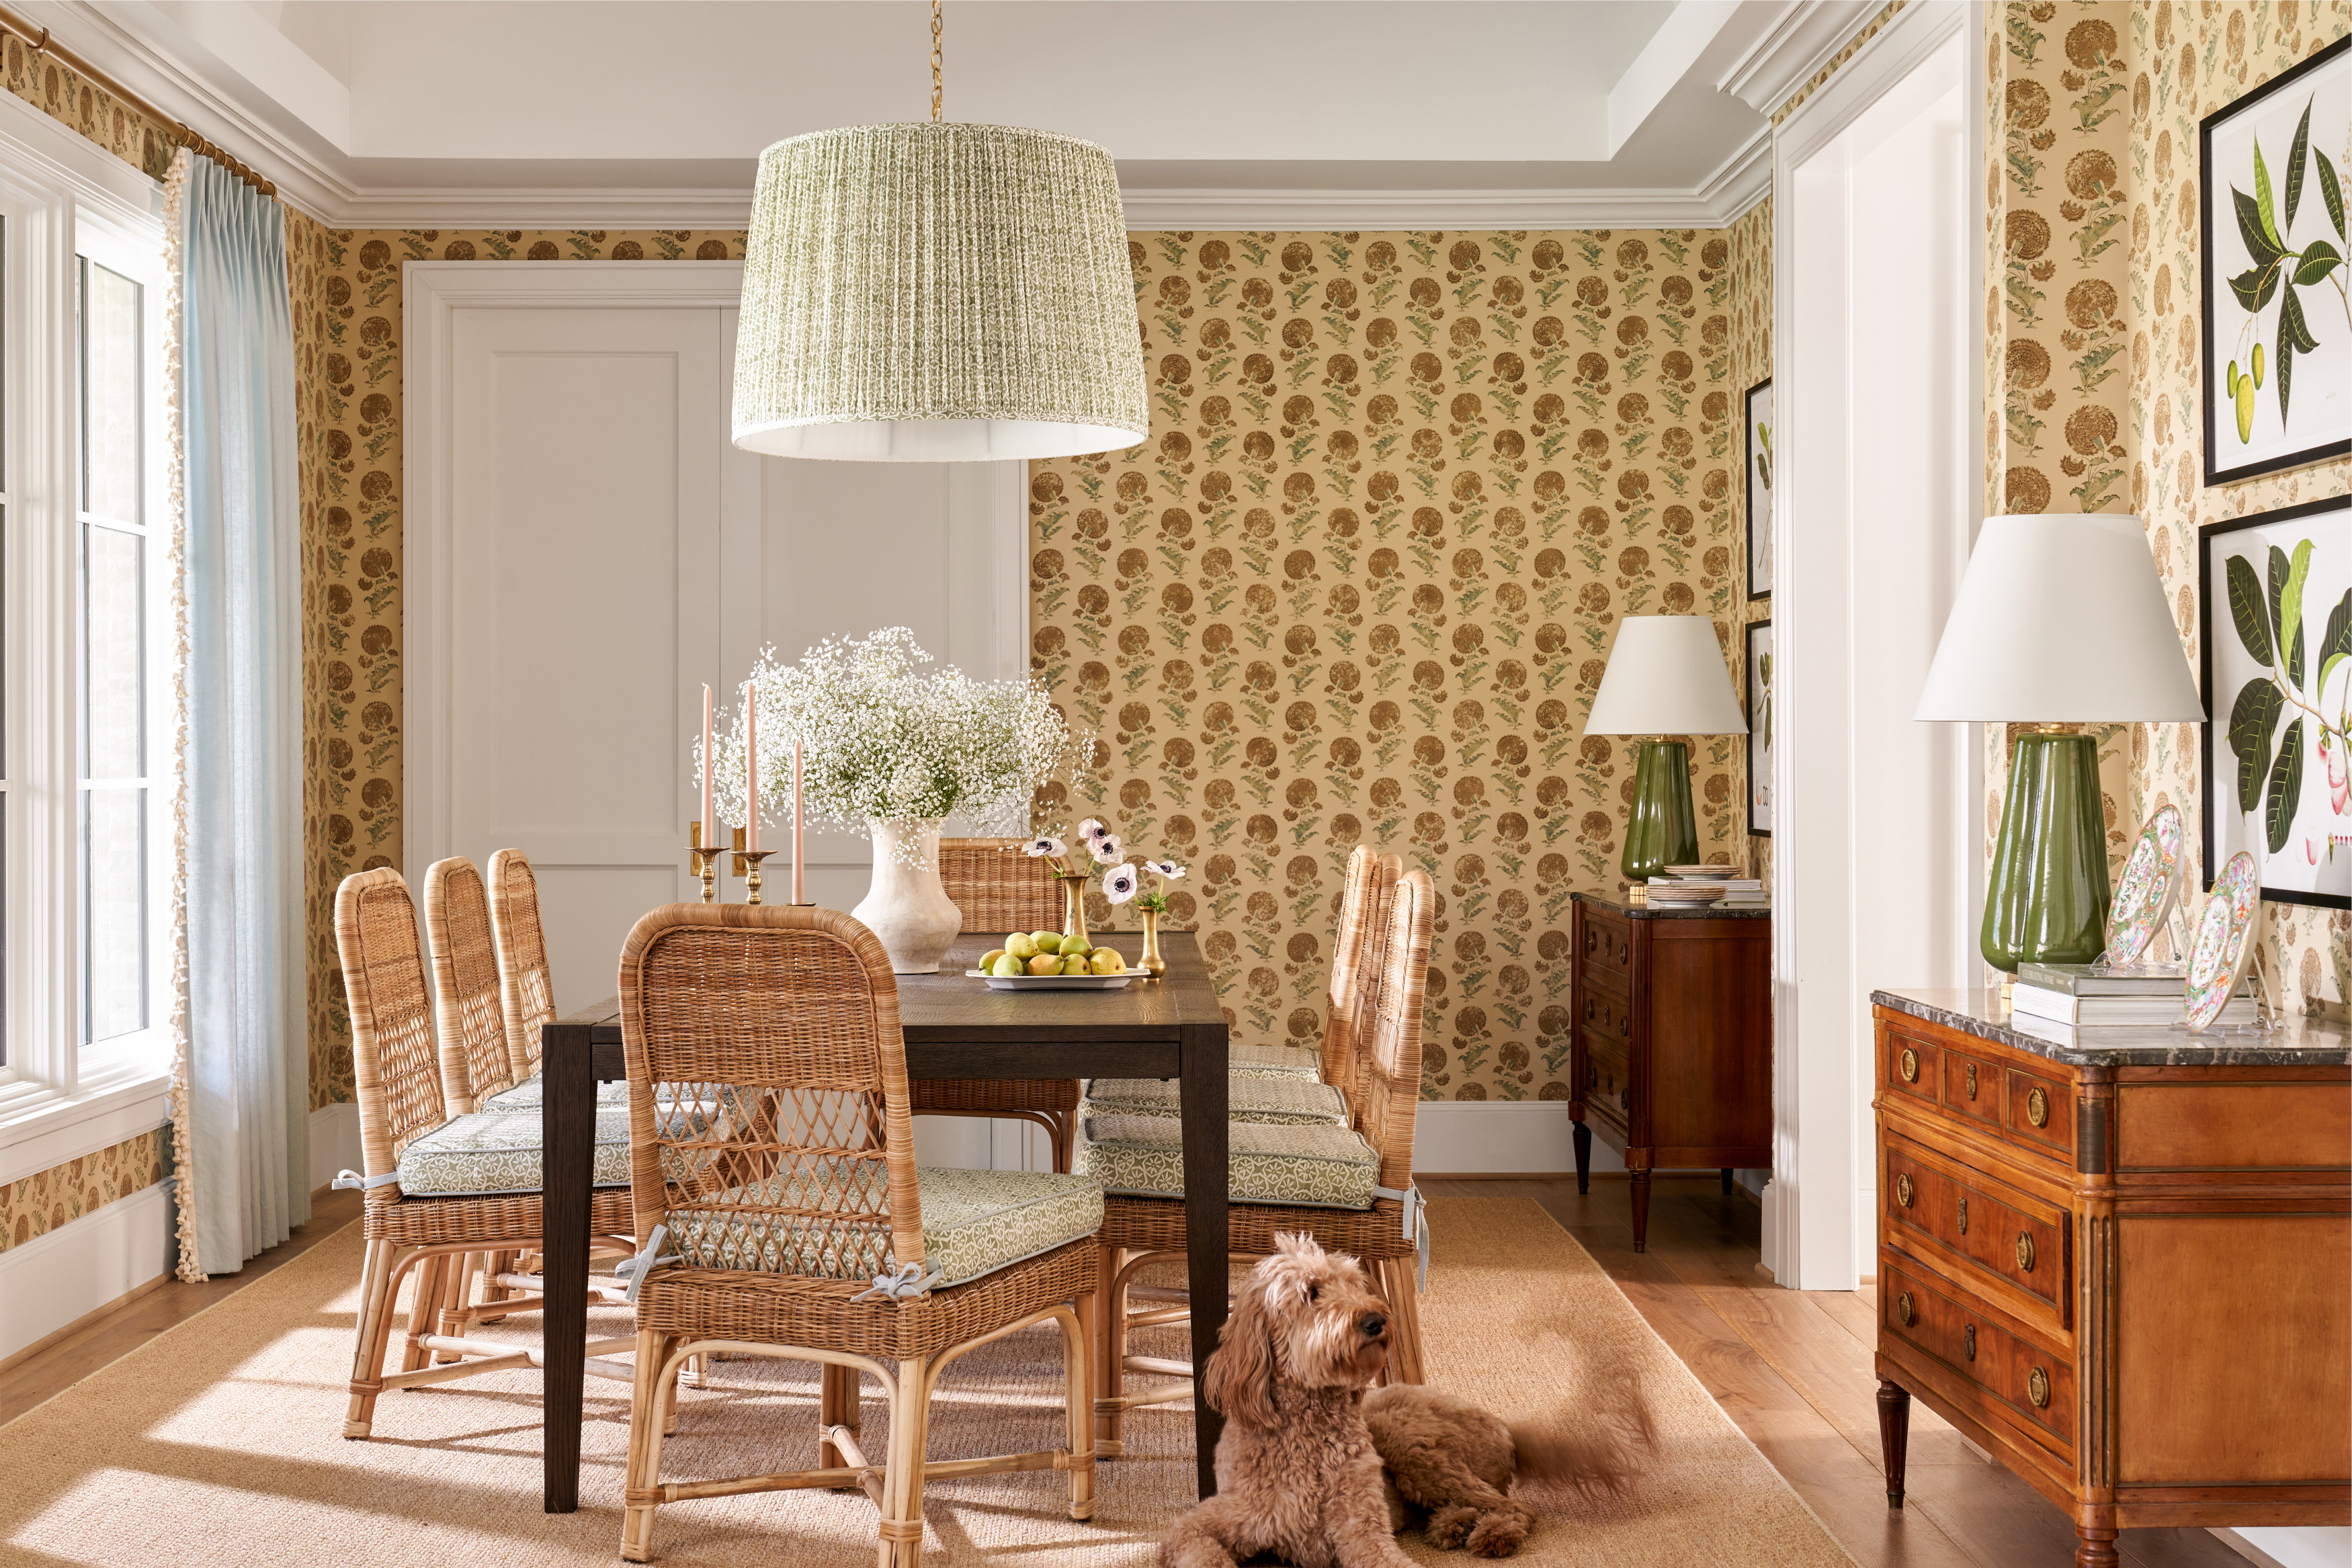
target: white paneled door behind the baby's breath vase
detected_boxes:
[405,261,1028,1029]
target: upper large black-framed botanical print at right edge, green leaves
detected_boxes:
[2197,38,2352,491]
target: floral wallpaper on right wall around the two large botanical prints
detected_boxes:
[1985,0,2352,1011]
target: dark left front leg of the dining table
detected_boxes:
[539,1022,595,1514]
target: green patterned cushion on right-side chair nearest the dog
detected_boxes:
[1073,1115,1381,1209]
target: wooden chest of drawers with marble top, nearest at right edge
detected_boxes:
[1872,992,2352,1568]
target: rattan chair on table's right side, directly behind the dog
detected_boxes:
[1077,870,1437,1458]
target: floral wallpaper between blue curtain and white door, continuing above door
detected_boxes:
[287,236,743,1107]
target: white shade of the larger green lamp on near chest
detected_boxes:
[1915,513,2204,724]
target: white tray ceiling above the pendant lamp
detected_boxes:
[41,0,1875,226]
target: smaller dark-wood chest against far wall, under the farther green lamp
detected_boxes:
[1569,894,1771,1253]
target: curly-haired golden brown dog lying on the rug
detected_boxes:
[1160,1237,1651,1568]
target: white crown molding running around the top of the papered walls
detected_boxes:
[24,0,1769,230]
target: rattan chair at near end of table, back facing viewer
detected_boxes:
[621,903,1103,1568]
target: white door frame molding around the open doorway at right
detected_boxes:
[1764,5,1985,1291]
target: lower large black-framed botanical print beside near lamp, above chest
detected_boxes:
[2197,496,2352,910]
